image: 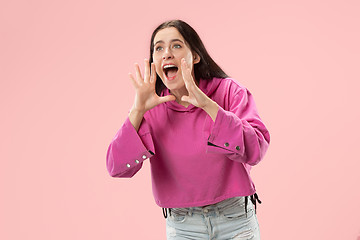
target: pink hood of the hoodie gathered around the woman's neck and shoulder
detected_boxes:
[160,78,222,112]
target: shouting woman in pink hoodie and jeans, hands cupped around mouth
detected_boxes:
[106,20,270,240]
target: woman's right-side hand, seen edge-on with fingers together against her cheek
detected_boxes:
[181,58,212,109]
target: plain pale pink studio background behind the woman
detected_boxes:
[0,0,360,240]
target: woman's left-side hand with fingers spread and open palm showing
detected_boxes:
[129,59,175,114]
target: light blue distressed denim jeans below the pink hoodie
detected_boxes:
[166,197,260,240]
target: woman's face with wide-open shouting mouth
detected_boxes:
[153,27,200,90]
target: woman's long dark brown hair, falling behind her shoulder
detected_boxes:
[149,20,228,96]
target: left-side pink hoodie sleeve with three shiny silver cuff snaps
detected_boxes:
[106,117,155,178]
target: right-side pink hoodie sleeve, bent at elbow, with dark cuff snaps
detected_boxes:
[206,84,270,166]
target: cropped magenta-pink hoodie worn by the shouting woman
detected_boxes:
[106,78,270,208]
